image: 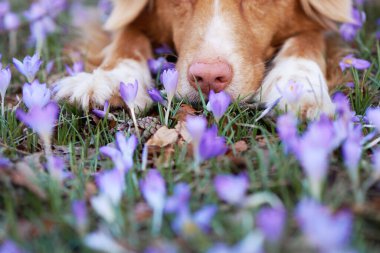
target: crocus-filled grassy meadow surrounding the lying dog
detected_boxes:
[0,0,380,253]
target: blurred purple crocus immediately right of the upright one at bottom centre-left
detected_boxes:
[165,183,191,213]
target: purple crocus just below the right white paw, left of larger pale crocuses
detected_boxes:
[277,113,298,153]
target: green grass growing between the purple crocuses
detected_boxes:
[0,1,380,252]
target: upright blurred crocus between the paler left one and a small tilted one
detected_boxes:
[140,170,166,212]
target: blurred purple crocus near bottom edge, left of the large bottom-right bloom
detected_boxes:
[256,207,286,243]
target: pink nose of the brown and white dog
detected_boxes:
[188,61,233,95]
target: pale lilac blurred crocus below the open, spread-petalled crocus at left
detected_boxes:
[96,169,125,206]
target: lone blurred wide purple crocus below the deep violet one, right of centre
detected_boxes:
[214,174,249,205]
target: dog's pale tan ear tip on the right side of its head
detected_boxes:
[301,0,353,28]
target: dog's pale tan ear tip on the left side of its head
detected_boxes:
[104,0,149,31]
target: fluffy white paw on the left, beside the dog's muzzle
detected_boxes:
[53,60,152,109]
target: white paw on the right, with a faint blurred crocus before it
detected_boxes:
[258,58,335,119]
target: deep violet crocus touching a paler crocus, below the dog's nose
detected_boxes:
[198,125,227,161]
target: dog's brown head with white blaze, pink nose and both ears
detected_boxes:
[106,0,351,100]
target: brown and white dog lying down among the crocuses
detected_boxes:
[54,0,352,118]
